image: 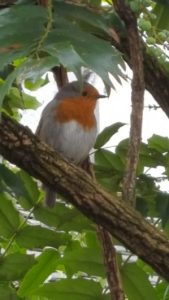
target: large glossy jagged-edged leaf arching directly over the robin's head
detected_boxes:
[44,18,124,86]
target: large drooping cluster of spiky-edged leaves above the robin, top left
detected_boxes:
[0,0,124,112]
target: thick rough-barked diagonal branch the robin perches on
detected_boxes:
[0,116,169,280]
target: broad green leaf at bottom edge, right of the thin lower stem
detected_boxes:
[121,263,159,300]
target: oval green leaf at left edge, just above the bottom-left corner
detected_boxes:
[0,253,35,281]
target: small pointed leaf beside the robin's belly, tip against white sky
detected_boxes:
[94,122,125,149]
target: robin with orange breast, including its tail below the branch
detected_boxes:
[36,81,106,207]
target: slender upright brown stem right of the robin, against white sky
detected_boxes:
[113,0,144,206]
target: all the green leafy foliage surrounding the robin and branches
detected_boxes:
[0,0,169,300]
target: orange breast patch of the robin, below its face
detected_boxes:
[55,97,96,129]
